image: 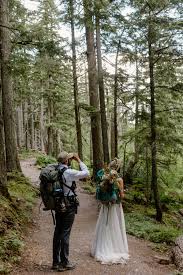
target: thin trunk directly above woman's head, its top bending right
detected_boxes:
[111,40,121,159]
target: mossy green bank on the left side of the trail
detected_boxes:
[0,173,38,274]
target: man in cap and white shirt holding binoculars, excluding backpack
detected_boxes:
[52,151,89,272]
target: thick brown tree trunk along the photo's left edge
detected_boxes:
[0,0,21,171]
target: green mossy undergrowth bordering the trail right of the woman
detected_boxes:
[123,186,183,250]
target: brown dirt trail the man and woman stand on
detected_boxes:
[11,159,175,275]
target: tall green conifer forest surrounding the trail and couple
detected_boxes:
[0,0,183,274]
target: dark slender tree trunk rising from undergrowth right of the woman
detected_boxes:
[148,13,162,222]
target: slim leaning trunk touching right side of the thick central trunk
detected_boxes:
[96,9,109,163]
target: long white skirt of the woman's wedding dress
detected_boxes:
[91,204,129,264]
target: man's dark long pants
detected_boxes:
[53,207,76,265]
